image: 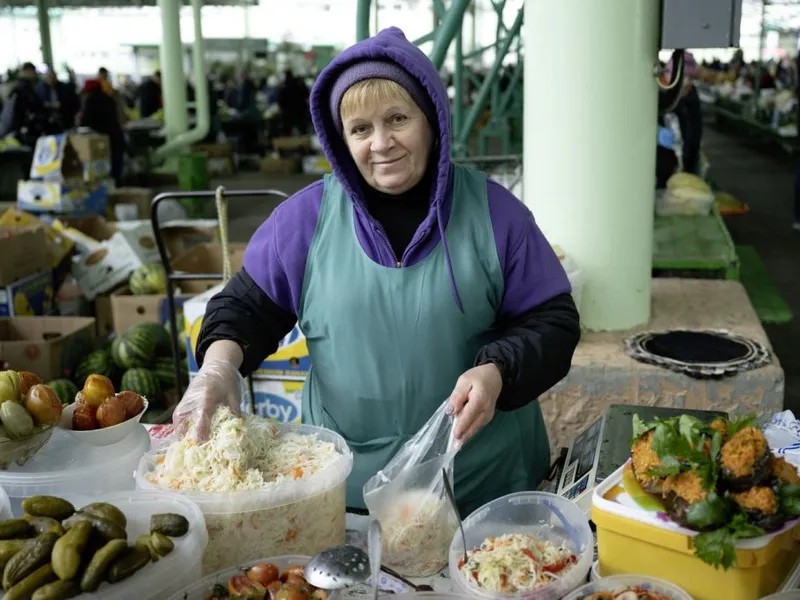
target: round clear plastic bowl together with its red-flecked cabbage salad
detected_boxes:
[448,492,594,600]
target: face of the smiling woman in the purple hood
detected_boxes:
[342,99,432,194]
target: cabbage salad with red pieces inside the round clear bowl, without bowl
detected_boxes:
[459,533,578,594]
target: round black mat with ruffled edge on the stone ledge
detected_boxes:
[625,329,771,379]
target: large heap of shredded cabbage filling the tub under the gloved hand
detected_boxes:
[145,407,345,573]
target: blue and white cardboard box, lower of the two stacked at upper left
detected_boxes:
[17,180,108,216]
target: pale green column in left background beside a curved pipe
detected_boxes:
[158,0,189,141]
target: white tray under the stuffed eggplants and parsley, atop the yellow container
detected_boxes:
[592,460,798,550]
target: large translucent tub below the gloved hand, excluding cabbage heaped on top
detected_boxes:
[136,423,353,574]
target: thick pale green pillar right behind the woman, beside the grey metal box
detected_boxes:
[523,0,659,331]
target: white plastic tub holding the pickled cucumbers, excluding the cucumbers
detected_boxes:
[46,492,208,600]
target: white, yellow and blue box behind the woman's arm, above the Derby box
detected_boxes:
[183,284,311,381]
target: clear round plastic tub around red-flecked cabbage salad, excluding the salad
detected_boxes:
[449,492,594,600]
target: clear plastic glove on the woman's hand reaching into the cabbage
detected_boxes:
[172,359,245,442]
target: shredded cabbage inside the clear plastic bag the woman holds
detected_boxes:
[378,490,458,577]
